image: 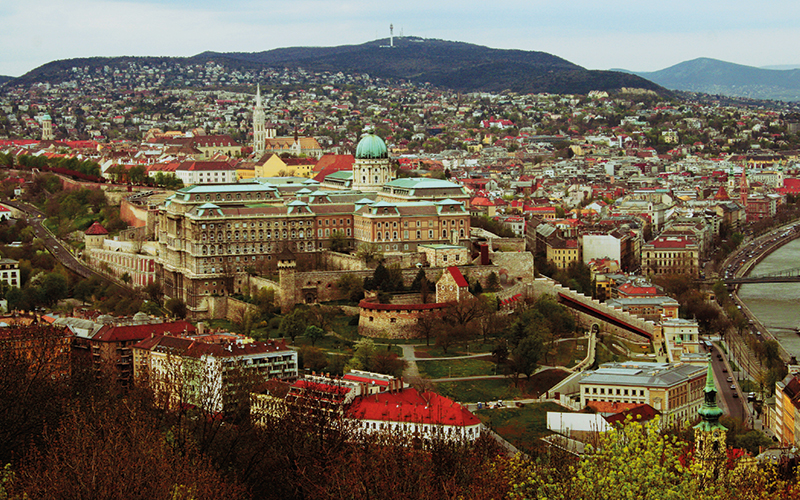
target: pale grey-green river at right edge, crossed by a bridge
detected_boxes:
[739,239,800,359]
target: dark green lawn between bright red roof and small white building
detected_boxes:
[475,403,569,450]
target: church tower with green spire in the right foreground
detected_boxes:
[694,360,728,480]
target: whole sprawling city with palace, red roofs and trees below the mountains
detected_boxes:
[0,51,800,499]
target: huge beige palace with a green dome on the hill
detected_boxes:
[155,134,470,317]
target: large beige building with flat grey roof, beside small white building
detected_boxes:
[579,361,706,427]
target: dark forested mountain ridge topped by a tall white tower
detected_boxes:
[10,37,671,96]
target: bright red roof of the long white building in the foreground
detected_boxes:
[347,388,480,427]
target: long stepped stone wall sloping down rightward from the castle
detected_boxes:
[532,278,661,342]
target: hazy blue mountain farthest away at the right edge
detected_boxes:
[620,57,800,101]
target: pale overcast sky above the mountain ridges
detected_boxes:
[6,0,800,76]
